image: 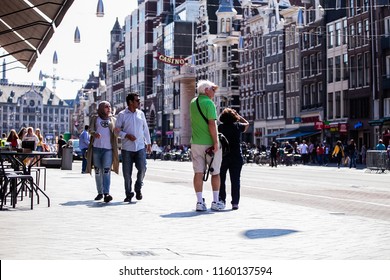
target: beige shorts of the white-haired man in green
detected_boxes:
[191,144,222,175]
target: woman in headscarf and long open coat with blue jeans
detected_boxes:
[86,101,119,203]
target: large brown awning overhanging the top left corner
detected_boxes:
[0,0,74,71]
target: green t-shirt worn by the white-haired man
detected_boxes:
[190,94,217,145]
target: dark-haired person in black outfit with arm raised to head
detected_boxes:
[218,108,249,210]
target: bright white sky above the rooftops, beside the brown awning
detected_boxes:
[0,0,138,99]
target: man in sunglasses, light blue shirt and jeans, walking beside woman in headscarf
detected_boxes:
[115,93,151,202]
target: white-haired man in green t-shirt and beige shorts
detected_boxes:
[190,80,224,211]
